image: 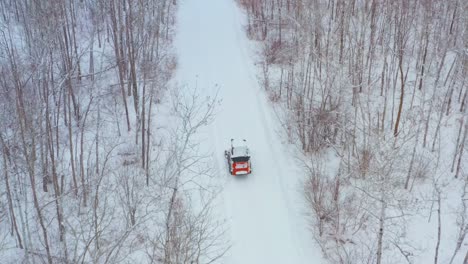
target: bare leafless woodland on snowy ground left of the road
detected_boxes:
[0,0,227,264]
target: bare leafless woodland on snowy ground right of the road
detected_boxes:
[238,0,468,263]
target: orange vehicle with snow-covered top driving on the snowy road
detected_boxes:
[224,139,252,175]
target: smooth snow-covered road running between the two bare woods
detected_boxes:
[175,0,324,264]
